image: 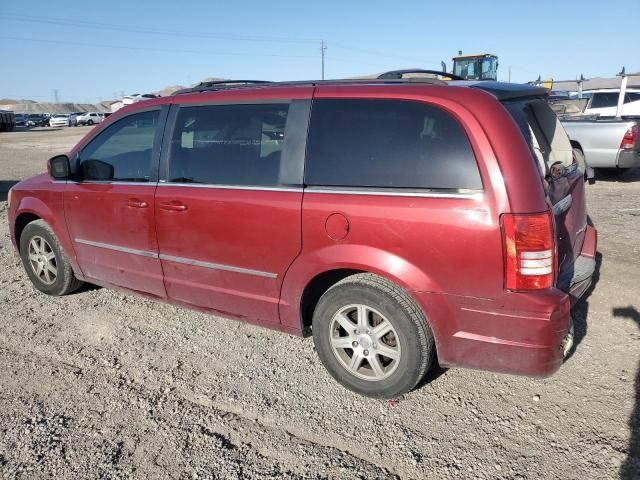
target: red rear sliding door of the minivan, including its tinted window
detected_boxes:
[156,94,312,324]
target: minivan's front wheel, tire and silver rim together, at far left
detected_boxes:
[20,220,82,295]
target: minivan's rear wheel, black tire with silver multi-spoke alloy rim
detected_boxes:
[313,273,435,398]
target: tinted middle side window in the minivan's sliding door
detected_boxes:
[169,104,289,186]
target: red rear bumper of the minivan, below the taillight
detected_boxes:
[419,289,571,377]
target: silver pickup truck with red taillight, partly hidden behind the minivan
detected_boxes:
[552,74,640,176]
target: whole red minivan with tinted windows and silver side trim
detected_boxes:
[9,72,596,398]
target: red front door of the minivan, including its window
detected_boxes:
[64,107,167,297]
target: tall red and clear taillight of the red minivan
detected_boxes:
[502,212,556,290]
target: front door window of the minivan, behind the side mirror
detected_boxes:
[80,110,160,182]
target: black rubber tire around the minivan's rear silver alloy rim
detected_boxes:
[313,273,435,398]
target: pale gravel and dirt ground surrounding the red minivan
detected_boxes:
[0,128,640,479]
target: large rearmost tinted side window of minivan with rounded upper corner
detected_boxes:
[305,100,482,189]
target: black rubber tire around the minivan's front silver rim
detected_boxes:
[20,220,83,296]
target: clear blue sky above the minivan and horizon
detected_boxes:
[0,0,640,102]
